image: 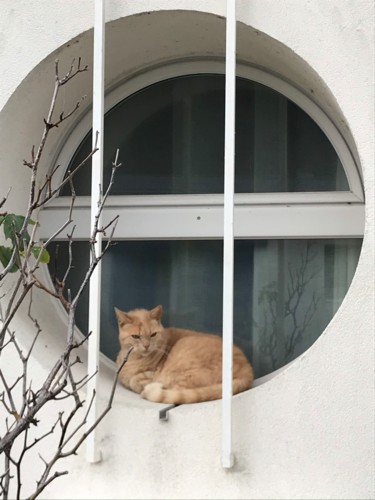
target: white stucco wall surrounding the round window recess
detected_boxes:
[0,0,375,499]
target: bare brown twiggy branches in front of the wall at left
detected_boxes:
[0,59,125,499]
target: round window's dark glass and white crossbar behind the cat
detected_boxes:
[44,69,361,377]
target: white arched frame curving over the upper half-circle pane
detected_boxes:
[52,59,365,203]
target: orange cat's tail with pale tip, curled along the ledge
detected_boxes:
[141,377,252,404]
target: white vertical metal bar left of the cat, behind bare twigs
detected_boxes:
[86,0,105,463]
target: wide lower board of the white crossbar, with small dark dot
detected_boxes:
[39,203,365,240]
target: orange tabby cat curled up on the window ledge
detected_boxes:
[115,305,253,404]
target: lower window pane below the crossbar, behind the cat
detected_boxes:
[49,239,361,377]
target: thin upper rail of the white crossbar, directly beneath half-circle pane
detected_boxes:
[45,191,363,210]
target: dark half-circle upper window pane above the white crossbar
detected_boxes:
[61,75,348,195]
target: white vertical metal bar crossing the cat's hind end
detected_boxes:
[222,0,236,469]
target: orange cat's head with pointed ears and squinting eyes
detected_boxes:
[115,306,164,355]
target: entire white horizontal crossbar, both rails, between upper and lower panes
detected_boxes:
[39,192,364,240]
